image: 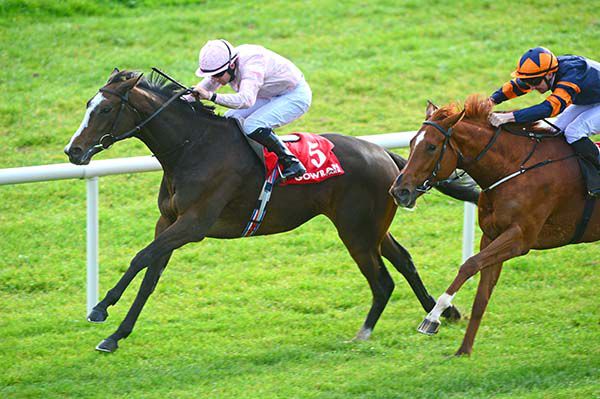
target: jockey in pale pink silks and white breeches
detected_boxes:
[192,40,312,180]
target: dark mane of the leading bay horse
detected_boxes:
[107,71,222,119]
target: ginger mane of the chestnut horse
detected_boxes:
[431,94,550,133]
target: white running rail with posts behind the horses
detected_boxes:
[0,131,475,314]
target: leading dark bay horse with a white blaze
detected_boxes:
[65,69,478,352]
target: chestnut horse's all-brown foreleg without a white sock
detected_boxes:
[456,264,502,356]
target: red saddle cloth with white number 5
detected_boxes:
[263,133,344,186]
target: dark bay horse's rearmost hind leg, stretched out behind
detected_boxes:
[381,232,460,320]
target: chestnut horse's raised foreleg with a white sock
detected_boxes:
[417,225,530,335]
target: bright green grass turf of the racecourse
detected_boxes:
[0,0,600,398]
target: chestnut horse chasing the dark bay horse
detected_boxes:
[390,96,600,355]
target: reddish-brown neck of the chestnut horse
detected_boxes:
[454,121,539,187]
